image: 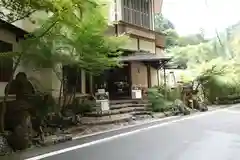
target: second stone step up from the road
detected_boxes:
[85,107,149,117]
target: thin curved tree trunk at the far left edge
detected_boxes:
[0,54,22,133]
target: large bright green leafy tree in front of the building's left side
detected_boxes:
[0,0,125,132]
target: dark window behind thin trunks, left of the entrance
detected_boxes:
[63,66,82,93]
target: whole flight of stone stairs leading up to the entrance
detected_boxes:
[81,100,151,125]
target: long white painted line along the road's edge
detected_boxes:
[25,106,236,160]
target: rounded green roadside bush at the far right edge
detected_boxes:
[195,58,240,103]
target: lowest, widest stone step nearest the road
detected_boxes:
[81,114,132,125]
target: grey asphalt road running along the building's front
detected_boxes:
[3,105,240,160]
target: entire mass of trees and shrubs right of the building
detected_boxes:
[156,16,240,102]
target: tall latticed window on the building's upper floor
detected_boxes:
[123,0,152,29]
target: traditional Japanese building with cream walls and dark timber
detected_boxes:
[0,0,170,99]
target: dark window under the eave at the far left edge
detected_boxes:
[0,41,13,82]
